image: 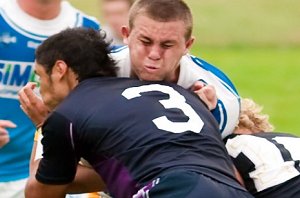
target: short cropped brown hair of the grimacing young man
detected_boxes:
[129,0,193,40]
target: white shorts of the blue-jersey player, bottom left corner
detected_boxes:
[0,179,27,198]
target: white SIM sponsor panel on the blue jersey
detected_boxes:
[0,60,38,99]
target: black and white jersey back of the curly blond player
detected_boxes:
[226,132,300,198]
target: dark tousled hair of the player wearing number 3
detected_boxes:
[35,27,116,82]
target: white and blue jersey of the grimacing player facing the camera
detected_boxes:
[111,47,240,137]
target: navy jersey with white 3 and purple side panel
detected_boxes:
[36,78,241,197]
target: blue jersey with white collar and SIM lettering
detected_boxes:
[0,0,99,182]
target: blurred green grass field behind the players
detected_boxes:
[70,0,300,135]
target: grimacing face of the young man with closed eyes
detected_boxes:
[122,14,193,82]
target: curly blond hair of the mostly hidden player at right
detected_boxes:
[235,98,274,133]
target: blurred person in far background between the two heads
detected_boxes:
[100,0,134,47]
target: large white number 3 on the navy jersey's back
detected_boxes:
[122,84,204,133]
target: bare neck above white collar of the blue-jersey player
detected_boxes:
[17,0,61,20]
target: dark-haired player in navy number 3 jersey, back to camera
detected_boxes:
[21,28,252,198]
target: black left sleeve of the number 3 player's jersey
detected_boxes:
[36,112,79,184]
